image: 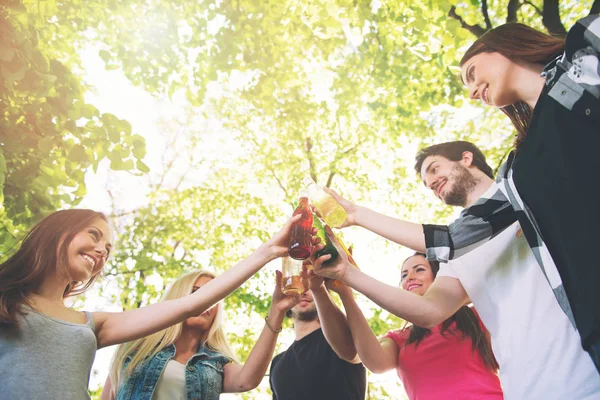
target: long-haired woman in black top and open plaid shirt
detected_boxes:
[454,15,600,371]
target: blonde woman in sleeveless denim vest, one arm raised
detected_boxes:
[101,271,297,400]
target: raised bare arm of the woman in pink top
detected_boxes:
[336,284,398,374]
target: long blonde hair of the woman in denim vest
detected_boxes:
[109,271,239,395]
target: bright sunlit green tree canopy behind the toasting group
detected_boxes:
[0,0,592,398]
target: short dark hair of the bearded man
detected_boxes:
[415,140,494,179]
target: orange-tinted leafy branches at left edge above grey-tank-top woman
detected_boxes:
[0,1,147,254]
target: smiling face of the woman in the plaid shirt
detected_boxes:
[461,52,519,108]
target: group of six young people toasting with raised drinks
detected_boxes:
[0,15,600,399]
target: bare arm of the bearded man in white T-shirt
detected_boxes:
[313,228,469,328]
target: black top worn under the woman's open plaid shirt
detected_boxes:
[513,19,600,348]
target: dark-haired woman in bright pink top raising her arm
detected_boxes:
[326,253,503,400]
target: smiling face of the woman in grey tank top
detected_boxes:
[67,218,112,282]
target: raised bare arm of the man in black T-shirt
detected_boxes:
[302,266,360,364]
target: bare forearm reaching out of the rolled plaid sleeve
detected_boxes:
[324,188,425,253]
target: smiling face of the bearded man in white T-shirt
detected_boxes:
[421,156,478,207]
